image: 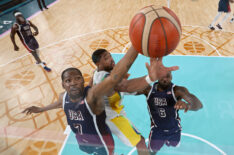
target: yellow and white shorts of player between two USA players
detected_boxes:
[106,115,141,147]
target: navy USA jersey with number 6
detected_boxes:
[147,83,181,132]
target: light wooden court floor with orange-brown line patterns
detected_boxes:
[0,0,234,155]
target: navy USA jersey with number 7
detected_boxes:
[63,87,113,152]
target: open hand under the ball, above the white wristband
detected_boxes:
[146,58,179,81]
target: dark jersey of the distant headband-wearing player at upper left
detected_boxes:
[15,21,39,52]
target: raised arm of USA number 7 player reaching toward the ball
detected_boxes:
[86,47,138,115]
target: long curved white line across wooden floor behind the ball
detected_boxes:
[0,24,234,68]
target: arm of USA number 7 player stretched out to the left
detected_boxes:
[22,92,64,115]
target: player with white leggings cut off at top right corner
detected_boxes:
[209,0,234,30]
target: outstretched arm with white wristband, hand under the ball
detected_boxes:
[115,58,179,93]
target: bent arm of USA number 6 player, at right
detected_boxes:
[174,86,203,112]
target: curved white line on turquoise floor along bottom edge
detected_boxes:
[128,133,227,155]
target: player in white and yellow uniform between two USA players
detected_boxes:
[92,49,147,153]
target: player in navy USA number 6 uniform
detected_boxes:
[138,72,202,155]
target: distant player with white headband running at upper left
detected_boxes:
[11,11,51,72]
